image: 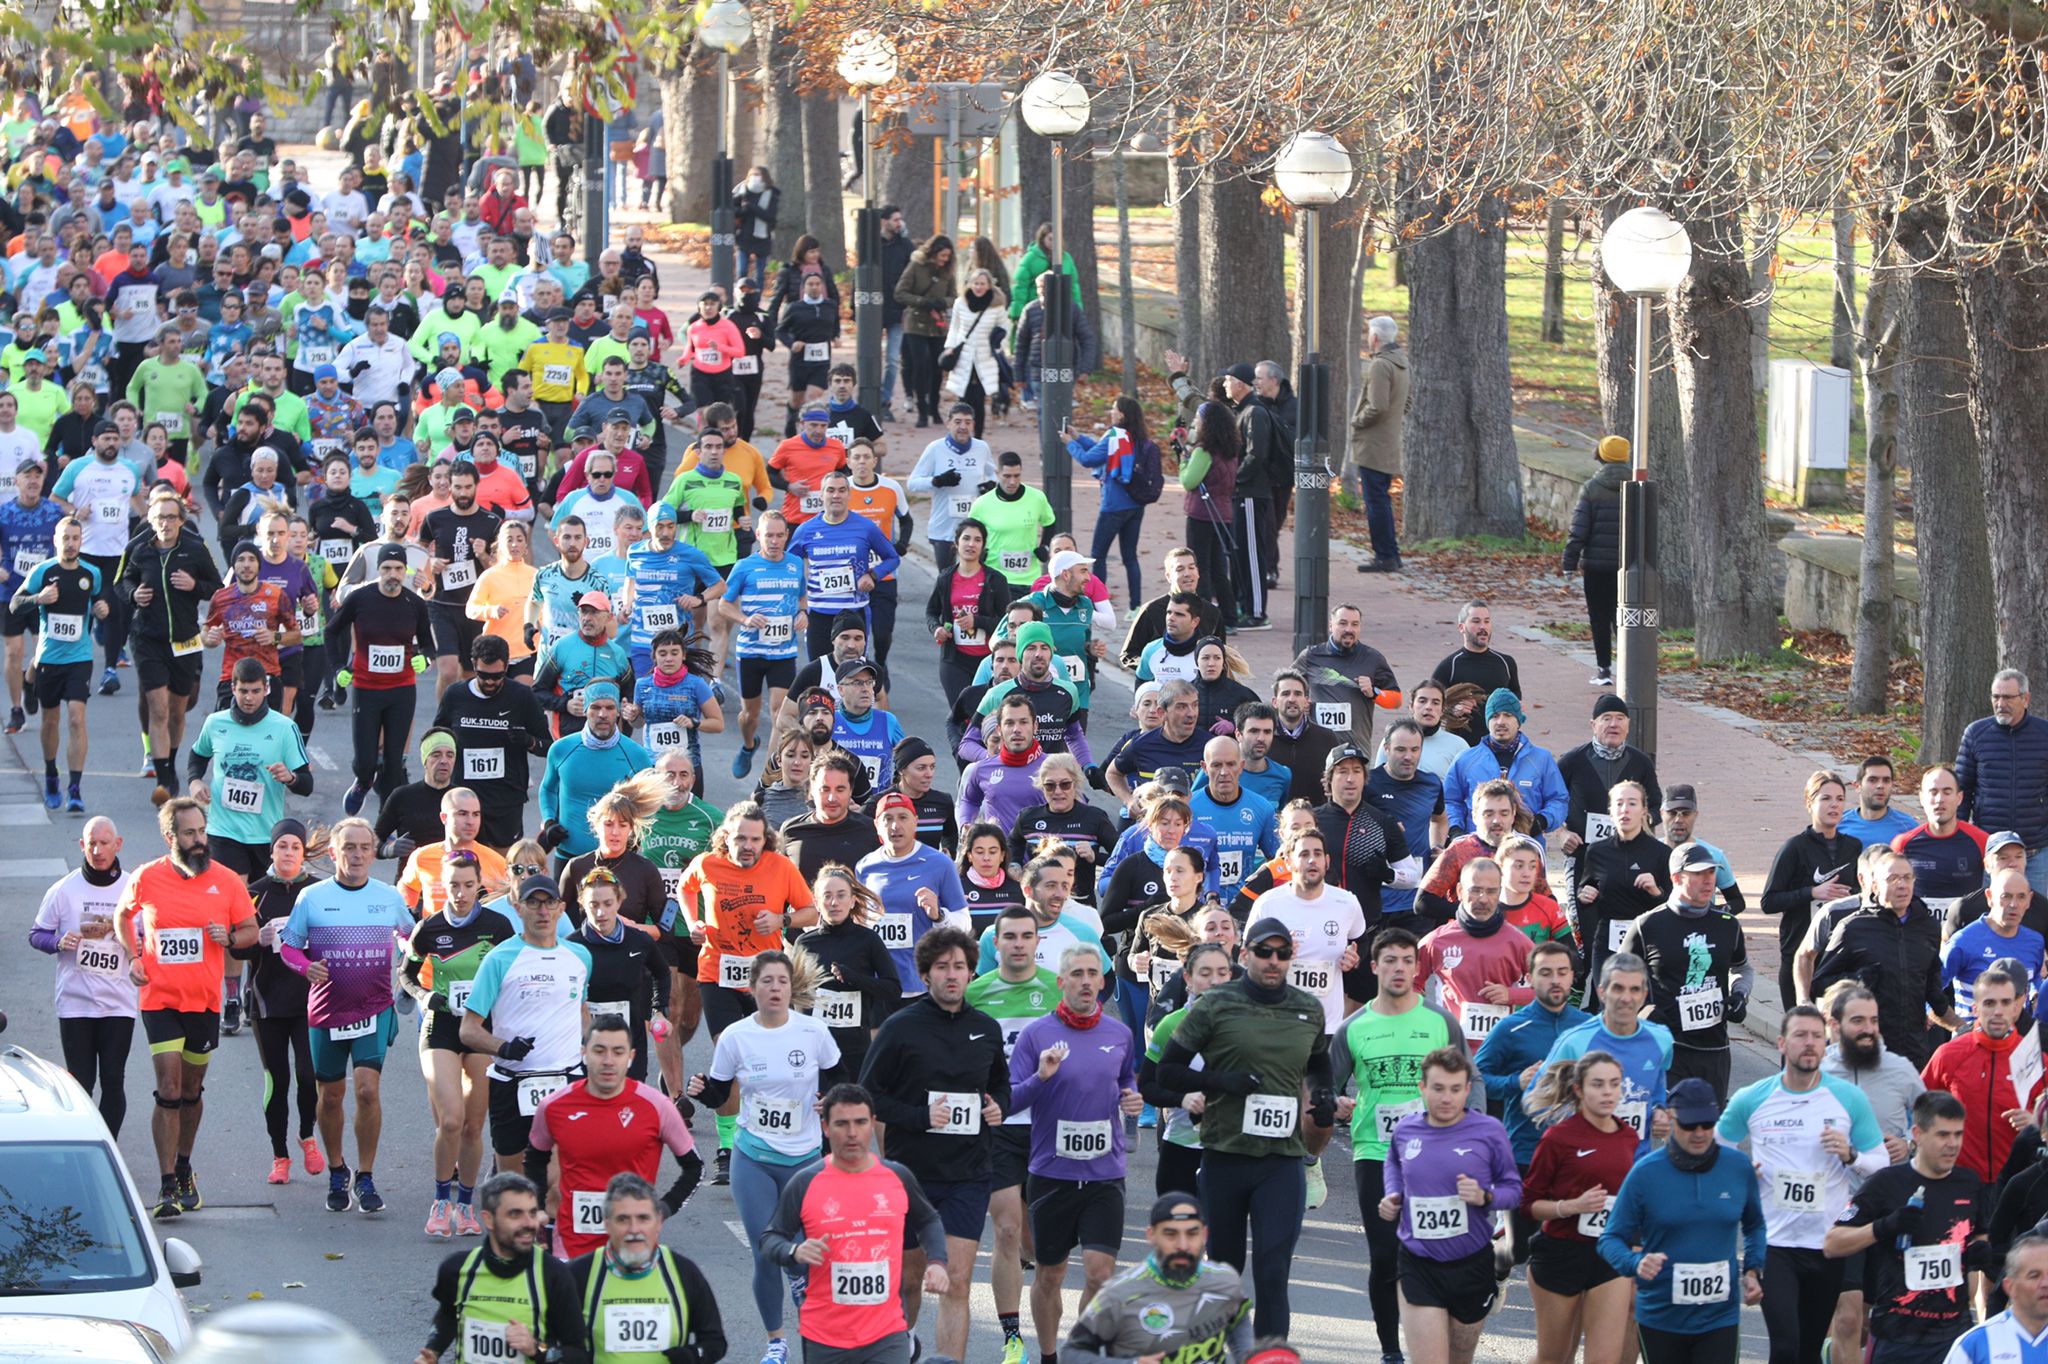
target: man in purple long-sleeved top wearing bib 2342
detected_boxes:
[1378,1047,1522,1364]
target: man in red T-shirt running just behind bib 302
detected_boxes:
[528,1014,705,1260]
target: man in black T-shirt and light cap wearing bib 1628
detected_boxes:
[1622,844,1757,1098]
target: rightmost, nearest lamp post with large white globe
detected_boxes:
[1599,207,1692,758]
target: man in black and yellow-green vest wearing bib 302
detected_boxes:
[569,1174,725,1364]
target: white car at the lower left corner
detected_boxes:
[0,1047,201,1350]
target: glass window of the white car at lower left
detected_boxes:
[0,1141,156,1296]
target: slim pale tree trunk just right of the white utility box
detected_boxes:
[1835,264,1898,715]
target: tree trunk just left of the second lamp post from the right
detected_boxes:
[1196,168,1292,379]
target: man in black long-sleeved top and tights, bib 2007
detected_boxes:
[328,545,434,815]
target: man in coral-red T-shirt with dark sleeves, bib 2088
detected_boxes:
[760,1085,948,1360]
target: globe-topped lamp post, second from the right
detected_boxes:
[1274,131,1356,653]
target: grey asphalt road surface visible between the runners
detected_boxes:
[0,540,1776,1364]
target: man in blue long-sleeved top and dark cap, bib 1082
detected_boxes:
[1599,1073,1761,1364]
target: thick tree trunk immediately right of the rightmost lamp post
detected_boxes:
[1671,193,1778,662]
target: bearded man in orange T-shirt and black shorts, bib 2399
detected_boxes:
[115,797,258,1219]
